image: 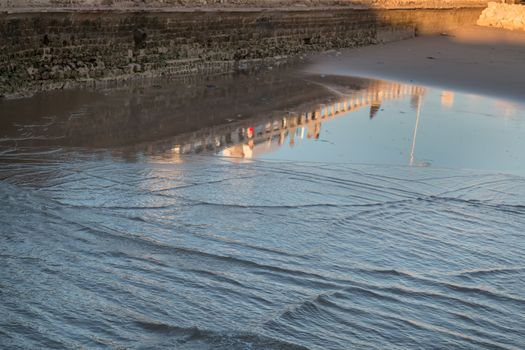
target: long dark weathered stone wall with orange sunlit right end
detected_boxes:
[0,8,481,96]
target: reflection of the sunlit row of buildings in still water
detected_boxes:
[158,82,425,158]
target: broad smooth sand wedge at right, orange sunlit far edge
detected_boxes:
[306,27,525,101]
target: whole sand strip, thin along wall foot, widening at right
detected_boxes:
[0,26,525,102]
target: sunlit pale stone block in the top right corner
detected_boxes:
[477,2,525,30]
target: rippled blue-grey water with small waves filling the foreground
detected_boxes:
[0,152,525,349]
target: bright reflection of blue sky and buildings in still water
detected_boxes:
[205,82,525,174]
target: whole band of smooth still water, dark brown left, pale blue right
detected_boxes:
[0,69,525,173]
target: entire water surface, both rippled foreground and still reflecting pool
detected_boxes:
[0,70,525,349]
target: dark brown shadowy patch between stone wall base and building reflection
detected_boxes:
[0,67,371,149]
